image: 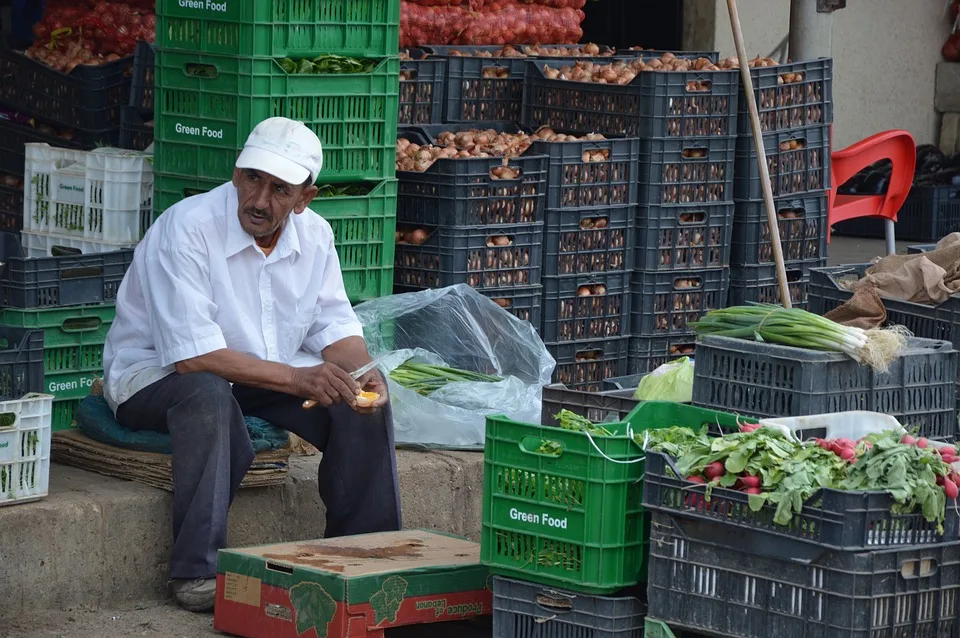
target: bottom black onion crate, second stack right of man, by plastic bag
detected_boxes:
[546,337,629,392]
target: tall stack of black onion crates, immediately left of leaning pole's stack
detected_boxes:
[523,51,738,382]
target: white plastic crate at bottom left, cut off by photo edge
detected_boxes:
[0,393,53,506]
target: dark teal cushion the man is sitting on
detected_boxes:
[76,395,289,454]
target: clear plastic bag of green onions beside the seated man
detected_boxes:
[355,284,556,450]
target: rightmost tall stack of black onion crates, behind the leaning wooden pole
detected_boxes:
[729,58,833,308]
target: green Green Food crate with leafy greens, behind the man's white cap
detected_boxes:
[154,50,400,183]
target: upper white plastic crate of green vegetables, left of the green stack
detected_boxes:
[23,143,153,243]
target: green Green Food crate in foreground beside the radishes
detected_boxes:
[480,401,738,594]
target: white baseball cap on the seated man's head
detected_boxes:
[237,117,323,184]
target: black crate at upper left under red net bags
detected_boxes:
[0,47,133,131]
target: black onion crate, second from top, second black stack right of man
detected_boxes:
[543,206,636,277]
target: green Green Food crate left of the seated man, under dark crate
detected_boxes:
[0,304,117,432]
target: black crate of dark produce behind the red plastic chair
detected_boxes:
[833,185,960,243]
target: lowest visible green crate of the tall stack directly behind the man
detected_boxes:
[153,173,397,303]
